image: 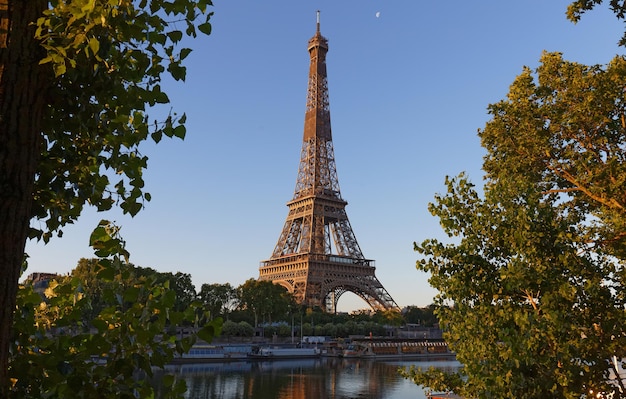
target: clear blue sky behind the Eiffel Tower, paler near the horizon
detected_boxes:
[27,0,624,310]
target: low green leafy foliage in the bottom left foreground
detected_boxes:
[9,223,221,398]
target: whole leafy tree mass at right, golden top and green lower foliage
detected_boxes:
[408,54,626,398]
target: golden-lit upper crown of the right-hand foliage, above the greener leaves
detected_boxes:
[480,53,626,258]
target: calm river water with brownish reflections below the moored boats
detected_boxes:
[156,358,459,399]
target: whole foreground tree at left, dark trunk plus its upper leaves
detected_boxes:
[0,0,211,396]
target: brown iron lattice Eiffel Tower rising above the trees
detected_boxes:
[259,11,400,313]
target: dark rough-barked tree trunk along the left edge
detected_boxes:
[0,0,47,398]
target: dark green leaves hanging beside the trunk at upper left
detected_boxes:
[32,0,212,240]
